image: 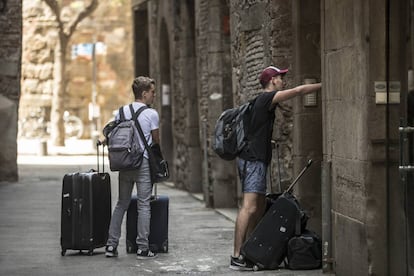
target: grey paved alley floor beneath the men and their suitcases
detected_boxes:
[0,140,322,276]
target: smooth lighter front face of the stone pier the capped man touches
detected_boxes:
[323,1,376,275]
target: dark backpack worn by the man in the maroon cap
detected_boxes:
[213,98,256,160]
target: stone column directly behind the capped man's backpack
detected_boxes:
[195,0,237,207]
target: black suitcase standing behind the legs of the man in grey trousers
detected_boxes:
[126,184,169,253]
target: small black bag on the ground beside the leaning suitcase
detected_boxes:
[286,230,322,270]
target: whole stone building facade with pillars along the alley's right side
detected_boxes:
[132,0,413,275]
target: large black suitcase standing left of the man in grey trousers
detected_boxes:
[60,144,111,256]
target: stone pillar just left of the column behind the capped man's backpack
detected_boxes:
[173,1,202,192]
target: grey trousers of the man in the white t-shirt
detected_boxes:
[106,158,152,251]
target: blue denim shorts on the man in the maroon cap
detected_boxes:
[237,158,267,194]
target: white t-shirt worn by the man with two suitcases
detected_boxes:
[115,102,159,158]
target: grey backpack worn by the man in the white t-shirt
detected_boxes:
[103,104,148,171]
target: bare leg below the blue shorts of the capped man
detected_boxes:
[233,193,265,257]
